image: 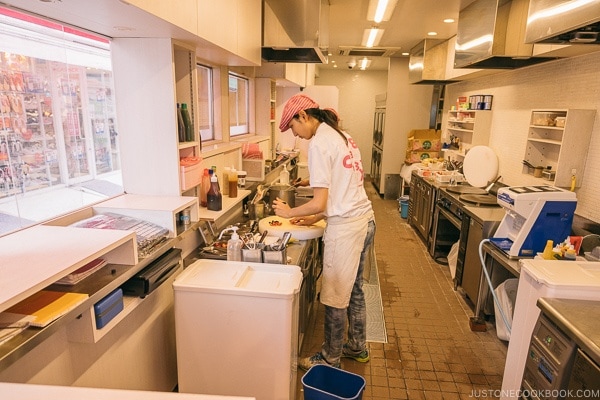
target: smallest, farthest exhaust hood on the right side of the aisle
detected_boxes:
[408,39,455,85]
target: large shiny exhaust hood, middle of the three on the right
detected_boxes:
[454,0,558,69]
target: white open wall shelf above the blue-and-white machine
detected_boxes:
[523,109,596,187]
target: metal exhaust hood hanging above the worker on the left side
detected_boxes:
[261,0,329,63]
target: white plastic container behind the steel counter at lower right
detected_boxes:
[501,259,600,399]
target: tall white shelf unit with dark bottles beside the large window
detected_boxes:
[111,38,200,196]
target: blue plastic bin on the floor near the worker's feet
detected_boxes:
[302,364,366,400]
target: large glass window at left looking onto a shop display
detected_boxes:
[0,7,123,236]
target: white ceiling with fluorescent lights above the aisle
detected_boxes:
[319,0,474,70]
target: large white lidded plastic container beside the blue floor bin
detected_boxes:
[173,259,302,400]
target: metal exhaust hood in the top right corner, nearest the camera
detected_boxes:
[525,0,600,44]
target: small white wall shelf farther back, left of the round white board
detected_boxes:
[445,110,492,159]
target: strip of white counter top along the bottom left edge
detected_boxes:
[0,383,255,400]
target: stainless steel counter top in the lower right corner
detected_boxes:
[537,297,600,364]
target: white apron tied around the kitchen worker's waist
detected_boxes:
[321,213,373,308]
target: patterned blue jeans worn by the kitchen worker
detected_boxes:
[321,220,375,365]
